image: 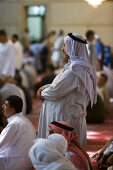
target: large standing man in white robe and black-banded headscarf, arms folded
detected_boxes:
[38,33,96,148]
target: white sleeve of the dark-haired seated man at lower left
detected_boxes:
[0,124,18,150]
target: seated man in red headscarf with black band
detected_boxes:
[48,121,93,170]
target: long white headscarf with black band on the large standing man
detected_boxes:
[64,34,97,106]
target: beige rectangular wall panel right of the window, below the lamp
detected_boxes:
[51,2,113,25]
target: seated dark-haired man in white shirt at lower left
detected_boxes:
[0,95,36,170]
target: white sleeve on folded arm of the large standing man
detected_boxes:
[41,72,78,101]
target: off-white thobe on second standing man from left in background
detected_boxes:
[14,41,23,70]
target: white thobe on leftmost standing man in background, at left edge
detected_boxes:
[0,43,16,77]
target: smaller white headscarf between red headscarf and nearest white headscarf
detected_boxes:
[48,133,68,155]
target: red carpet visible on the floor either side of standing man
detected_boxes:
[27,99,113,170]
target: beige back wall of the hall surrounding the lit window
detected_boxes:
[0,0,113,46]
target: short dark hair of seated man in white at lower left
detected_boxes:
[6,95,23,113]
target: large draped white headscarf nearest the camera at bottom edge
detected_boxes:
[29,139,76,170]
